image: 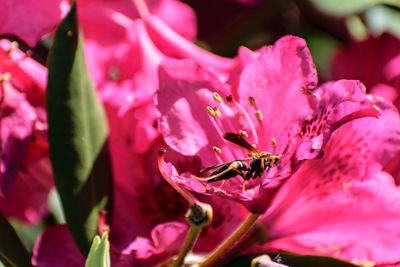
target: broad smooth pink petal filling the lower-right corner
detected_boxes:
[266,173,400,264]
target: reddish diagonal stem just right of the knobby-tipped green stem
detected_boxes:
[200,213,260,267]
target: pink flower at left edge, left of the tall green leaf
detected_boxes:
[0,40,53,223]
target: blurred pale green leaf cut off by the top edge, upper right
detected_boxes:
[311,0,399,17]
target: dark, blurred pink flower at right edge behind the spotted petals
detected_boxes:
[332,34,400,184]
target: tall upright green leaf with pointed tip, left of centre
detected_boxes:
[46,4,112,255]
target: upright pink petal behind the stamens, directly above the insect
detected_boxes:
[238,36,317,151]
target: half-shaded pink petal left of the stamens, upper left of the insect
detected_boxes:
[156,59,238,168]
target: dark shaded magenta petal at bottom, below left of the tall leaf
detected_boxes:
[32,225,85,267]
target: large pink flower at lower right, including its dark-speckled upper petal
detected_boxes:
[261,97,400,264]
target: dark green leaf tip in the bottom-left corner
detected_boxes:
[0,213,32,267]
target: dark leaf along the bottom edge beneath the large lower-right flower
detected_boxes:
[225,253,356,267]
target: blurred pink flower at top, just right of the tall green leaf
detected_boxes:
[78,0,234,153]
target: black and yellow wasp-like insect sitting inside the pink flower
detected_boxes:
[192,133,281,192]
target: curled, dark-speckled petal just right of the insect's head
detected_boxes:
[296,80,379,160]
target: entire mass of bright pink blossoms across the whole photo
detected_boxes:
[0,0,400,266]
